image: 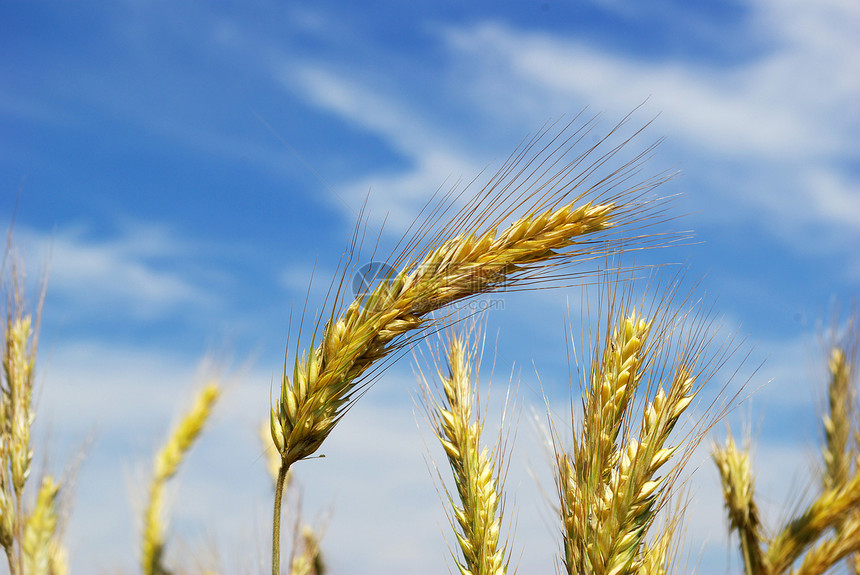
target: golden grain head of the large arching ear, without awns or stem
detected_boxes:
[271,200,613,465]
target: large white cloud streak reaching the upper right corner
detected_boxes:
[436,2,860,249]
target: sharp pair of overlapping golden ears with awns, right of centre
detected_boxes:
[550,281,735,575]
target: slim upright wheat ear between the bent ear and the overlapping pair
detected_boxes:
[424,333,509,575]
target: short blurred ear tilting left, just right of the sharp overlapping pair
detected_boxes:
[712,434,764,575]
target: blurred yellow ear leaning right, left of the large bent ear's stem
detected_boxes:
[141,383,221,575]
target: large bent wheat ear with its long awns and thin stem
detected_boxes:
[269,112,670,575]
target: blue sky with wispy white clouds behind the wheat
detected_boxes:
[0,0,860,573]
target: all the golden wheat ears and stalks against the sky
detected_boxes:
[0,118,860,575]
